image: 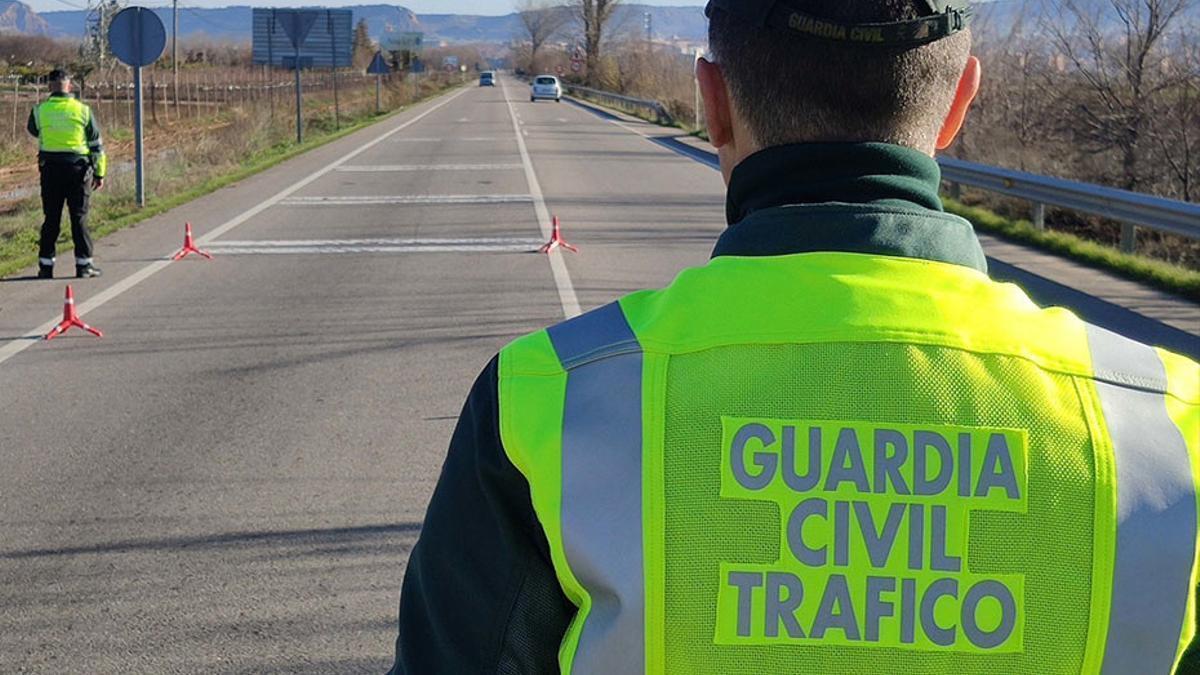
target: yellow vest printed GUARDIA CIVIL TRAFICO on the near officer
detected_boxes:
[499,253,1200,675]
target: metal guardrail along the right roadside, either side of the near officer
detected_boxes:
[569,86,1200,253]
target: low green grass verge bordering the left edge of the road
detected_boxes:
[0,86,456,277]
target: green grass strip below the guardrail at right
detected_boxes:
[942,198,1200,301]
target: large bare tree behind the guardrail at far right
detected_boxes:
[1044,0,1195,190]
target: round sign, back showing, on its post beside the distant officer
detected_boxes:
[108,7,167,208]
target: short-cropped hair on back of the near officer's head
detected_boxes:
[708,0,971,151]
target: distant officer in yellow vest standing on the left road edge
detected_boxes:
[28,70,108,279]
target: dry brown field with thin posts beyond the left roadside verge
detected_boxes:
[0,67,457,216]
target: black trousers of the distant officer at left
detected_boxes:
[38,157,91,259]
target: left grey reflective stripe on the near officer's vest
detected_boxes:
[547,303,646,674]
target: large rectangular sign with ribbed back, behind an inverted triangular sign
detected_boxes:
[253,7,354,70]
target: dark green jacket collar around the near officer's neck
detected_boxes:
[713,143,988,271]
